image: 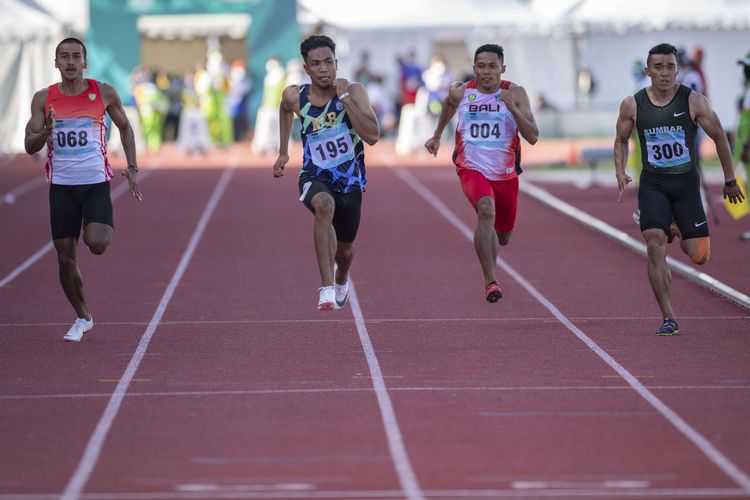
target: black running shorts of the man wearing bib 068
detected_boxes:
[49,182,115,240]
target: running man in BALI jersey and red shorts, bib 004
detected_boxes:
[425,44,539,302]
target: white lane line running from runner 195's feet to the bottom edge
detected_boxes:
[349,276,424,500]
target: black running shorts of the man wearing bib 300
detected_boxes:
[638,170,708,240]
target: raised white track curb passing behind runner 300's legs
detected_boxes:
[521,182,750,311]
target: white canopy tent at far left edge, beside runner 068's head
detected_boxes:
[0,0,63,154]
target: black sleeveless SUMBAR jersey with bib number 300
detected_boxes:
[634,85,698,174]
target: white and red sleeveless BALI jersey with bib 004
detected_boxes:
[453,80,520,181]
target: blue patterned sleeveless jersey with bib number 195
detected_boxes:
[299,84,367,193]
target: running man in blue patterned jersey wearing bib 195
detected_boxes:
[273,35,380,311]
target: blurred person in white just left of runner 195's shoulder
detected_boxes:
[250,57,286,155]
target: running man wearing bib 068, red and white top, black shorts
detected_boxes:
[25,38,142,342]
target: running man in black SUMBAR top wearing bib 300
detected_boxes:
[614,43,743,336]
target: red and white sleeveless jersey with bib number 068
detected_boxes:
[44,78,112,185]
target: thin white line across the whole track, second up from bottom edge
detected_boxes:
[0,385,750,401]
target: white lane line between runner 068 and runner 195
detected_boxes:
[61,167,235,500]
